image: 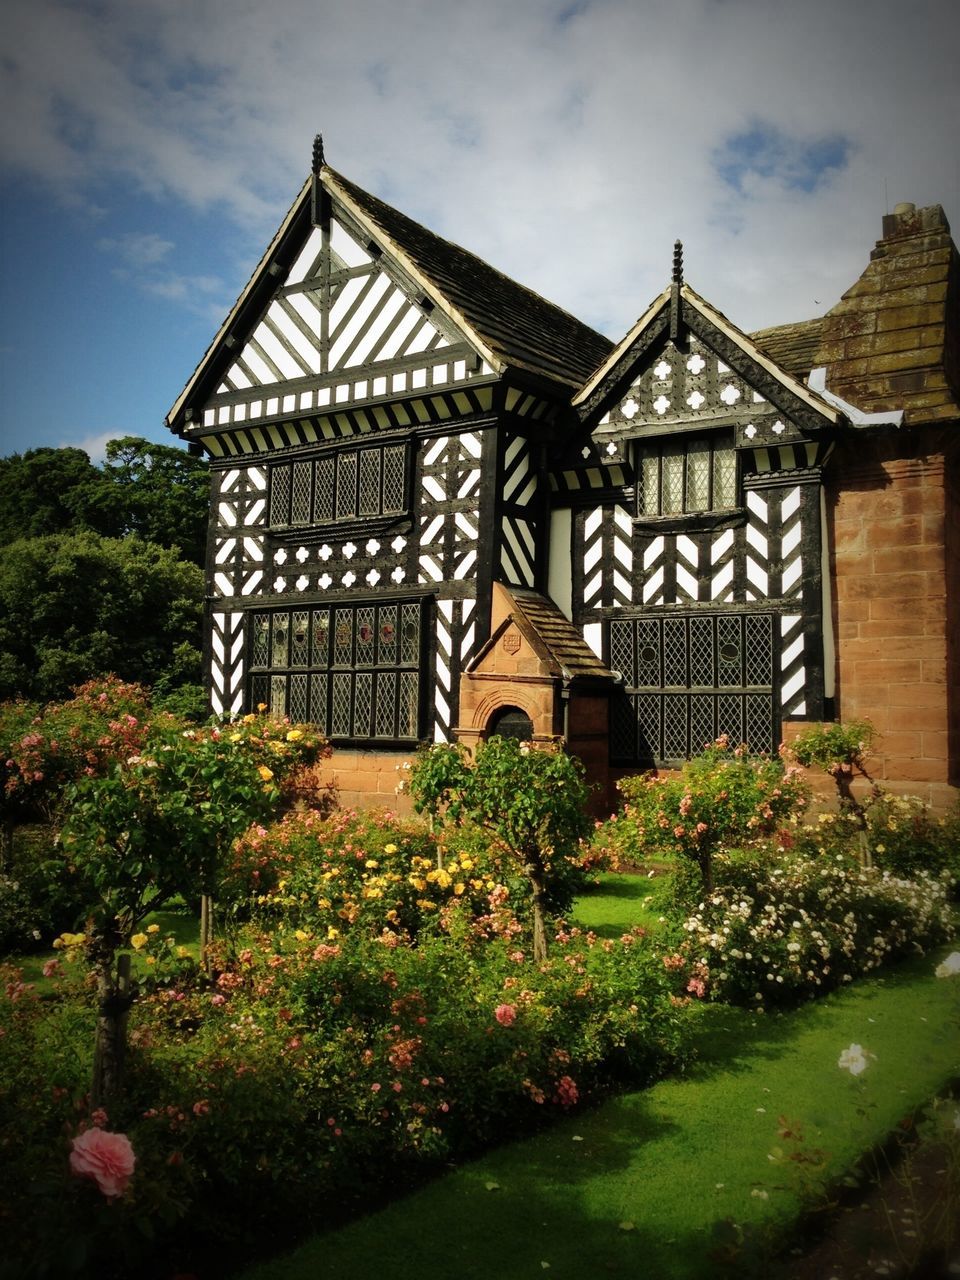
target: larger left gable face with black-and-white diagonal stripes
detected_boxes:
[168,186,494,456]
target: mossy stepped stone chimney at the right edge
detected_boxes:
[817,204,960,425]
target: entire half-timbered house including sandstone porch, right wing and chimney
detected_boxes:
[168,148,960,800]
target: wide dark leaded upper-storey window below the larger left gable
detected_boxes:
[270,444,407,529]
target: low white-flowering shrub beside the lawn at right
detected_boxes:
[668,856,952,1007]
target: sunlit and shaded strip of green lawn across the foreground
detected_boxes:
[243,942,960,1280]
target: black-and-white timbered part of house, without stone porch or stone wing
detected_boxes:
[168,154,844,764]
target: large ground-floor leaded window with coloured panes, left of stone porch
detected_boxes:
[250,600,424,741]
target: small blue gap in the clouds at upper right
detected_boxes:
[713,122,852,195]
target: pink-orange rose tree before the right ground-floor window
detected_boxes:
[598,737,808,890]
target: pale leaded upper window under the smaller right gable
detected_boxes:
[636,434,737,516]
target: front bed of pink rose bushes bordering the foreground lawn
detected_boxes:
[0,928,687,1275]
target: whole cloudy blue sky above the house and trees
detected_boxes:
[0,0,960,461]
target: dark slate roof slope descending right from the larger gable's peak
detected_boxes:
[321,166,613,387]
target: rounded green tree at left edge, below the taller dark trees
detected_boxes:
[0,532,204,701]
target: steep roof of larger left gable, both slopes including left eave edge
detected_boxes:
[166,165,611,429]
